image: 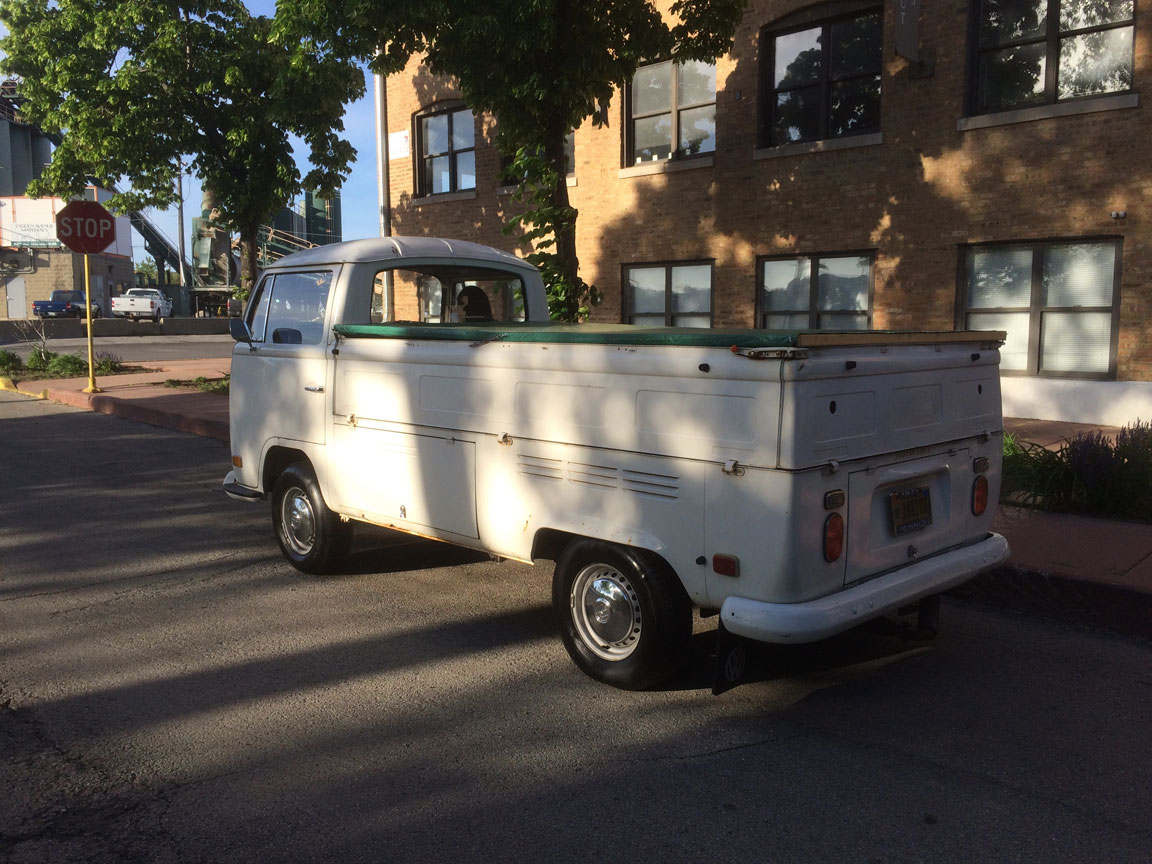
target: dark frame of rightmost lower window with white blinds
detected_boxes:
[956,235,1124,381]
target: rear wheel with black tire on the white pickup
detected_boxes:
[552,540,692,690]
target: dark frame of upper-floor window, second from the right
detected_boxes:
[757,8,884,149]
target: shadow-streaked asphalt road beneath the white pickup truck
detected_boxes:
[0,393,1152,864]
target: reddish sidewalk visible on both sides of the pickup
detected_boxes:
[0,358,1152,638]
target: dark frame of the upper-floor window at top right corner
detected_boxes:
[965,0,1136,116]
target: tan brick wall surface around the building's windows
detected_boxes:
[388,0,1152,380]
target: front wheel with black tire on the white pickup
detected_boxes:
[272,462,353,575]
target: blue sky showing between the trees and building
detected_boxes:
[132,0,380,262]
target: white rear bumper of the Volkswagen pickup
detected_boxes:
[720,533,1008,643]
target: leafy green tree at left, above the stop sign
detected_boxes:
[0,0,364,287]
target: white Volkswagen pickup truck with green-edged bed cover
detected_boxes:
[225,237,1008,689]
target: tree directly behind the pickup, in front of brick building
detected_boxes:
[276,0,745,320]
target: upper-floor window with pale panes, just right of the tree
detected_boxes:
[624,60,717,165]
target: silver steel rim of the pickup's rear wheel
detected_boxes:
[569,563,643,661]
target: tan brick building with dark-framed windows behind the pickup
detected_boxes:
[386,0,1152,424]
